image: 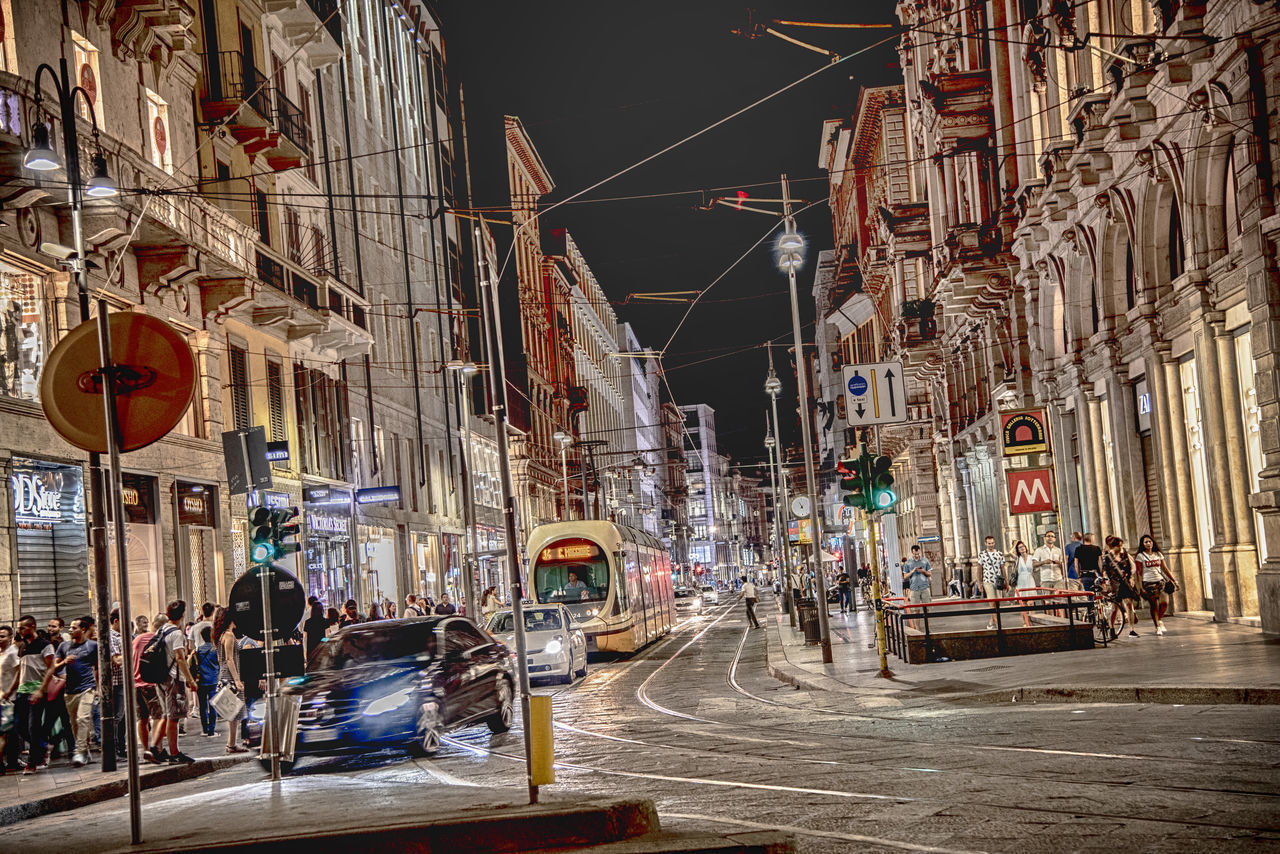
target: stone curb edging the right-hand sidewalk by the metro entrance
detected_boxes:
[765,614,1280,705]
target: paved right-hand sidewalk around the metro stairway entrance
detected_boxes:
[762,594,1280,708]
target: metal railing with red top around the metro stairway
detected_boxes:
[883,588,1093,662]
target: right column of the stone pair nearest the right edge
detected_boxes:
[1213,324,1258,616]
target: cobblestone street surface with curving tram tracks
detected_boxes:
[10,594,1280,854]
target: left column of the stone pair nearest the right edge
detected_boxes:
[1192,312,1243,622]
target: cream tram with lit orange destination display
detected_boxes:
[529,521,676,653]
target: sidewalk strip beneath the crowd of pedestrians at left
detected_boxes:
[0,720,257,827]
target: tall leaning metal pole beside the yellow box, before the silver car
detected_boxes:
[480,236,540,804]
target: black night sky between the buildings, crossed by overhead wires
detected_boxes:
[439,0,901,462]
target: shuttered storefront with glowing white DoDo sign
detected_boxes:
[10,457,90,625]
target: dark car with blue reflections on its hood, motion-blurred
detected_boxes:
[284,617,515,757]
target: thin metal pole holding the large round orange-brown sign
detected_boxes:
[94,303,142,845]
